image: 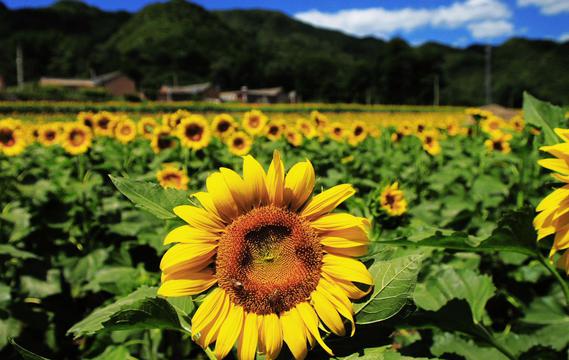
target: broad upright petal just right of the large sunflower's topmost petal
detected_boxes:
[284,160,316,210]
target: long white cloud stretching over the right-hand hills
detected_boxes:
[295,0,513,38]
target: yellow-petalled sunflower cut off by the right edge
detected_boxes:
[533,129,569,273]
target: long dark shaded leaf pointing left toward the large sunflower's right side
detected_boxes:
[381,208,539,256]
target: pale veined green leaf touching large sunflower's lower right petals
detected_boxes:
[354,254,422,324]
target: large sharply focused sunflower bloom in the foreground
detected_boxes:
[158,152,373,359]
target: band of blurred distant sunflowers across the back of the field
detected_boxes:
[0,109,524,156]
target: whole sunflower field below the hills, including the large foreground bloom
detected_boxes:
[0,94,569,360]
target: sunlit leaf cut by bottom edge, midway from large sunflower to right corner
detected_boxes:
[431,333,508,360]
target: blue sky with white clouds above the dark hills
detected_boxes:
[5,0,569,46]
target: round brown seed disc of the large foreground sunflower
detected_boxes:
[215,206,323,314]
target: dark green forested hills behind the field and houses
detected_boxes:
[0,0,569,106]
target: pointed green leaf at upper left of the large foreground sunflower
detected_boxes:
[109,175,188,220]
